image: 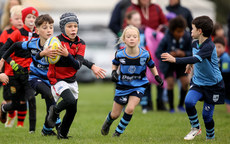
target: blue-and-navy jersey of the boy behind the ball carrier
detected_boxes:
[21,38,50,85]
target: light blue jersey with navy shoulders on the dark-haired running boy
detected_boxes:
[192,38,223,86]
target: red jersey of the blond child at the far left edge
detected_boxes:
[0,26,17,76]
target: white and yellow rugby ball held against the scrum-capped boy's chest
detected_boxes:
[44,37,61,64]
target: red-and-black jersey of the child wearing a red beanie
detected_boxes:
[0,25,38,74]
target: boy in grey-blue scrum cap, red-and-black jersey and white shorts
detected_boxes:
[47,13,105,139]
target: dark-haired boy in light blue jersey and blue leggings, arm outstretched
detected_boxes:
[161,16,225,140]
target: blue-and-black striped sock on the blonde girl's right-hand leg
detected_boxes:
[116,112,133,134]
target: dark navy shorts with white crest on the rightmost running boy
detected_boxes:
[190,80,225,104]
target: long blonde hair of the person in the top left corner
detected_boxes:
[1,0,22,30]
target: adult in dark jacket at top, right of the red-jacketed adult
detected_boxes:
[166,0,193,31]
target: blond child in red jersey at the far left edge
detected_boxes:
[0,5,23,127]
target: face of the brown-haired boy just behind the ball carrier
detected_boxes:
[36,22,54,40]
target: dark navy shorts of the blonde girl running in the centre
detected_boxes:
[113,91,144,105]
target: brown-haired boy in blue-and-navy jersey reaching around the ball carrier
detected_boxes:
[0,14,61,136]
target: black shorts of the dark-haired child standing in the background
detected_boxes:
[164,63,187,78]
